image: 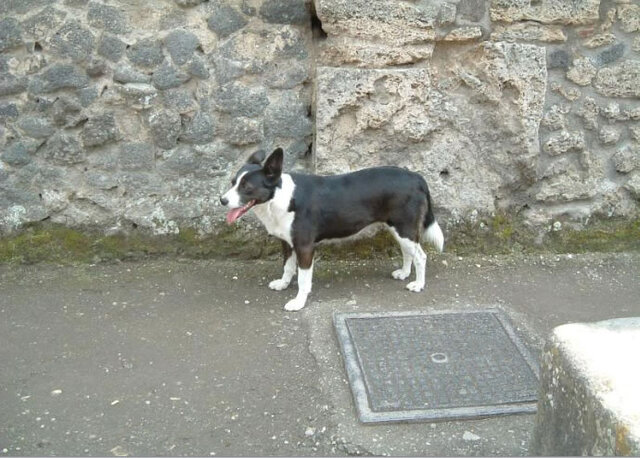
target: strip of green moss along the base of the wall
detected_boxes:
[0,214,640,264]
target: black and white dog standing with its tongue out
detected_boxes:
[220,148,444,310]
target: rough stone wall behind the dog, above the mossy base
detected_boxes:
[0,0,640,242]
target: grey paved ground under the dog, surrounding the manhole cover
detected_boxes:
[0,253,640,456]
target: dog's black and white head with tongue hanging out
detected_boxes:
[220,148,283,224]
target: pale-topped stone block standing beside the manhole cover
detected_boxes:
[532,318,640,456]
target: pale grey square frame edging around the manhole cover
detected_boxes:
[333,308,540,423]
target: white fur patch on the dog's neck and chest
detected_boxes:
[253,174,295,246]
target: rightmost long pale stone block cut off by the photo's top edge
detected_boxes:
[490,0,600,24]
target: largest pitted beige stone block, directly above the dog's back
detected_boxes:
[315,43,547,213]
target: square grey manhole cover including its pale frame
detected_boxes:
[334,309,538,423]
